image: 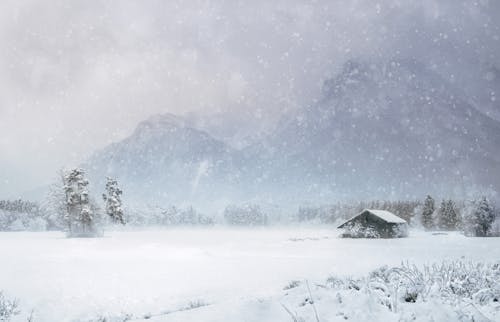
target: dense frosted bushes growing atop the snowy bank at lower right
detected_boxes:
[327,261,500,309]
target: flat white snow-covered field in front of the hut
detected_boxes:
[0,227,500,322]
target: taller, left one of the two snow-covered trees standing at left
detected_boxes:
[63,168,98,237]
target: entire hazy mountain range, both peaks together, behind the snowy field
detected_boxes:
[86,60,500,208]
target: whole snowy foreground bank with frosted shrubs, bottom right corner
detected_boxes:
[280,260,500,322]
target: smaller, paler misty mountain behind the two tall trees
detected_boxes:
[84,114,240,202]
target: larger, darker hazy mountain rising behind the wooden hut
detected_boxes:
[261,61,500,197]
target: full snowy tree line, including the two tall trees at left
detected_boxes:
[0,181,500,236]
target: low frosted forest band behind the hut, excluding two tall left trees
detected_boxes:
[0,196,500,236]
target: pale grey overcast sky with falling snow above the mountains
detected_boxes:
[0,0,500,197]
